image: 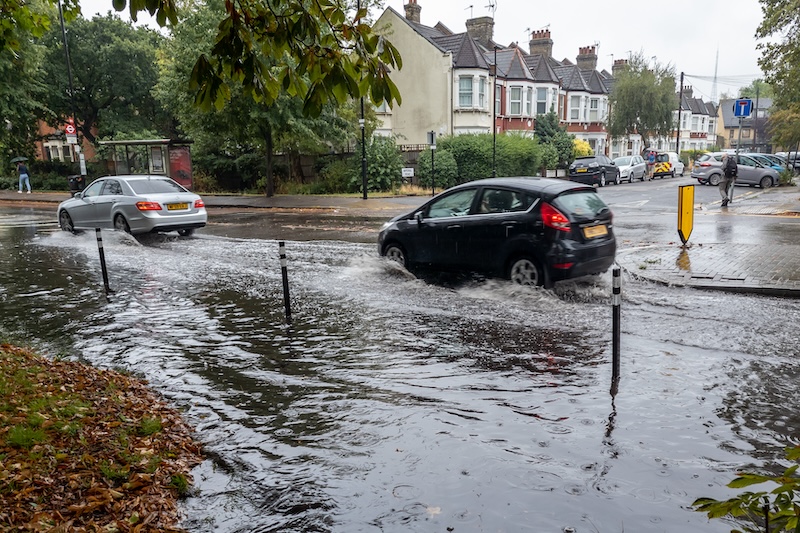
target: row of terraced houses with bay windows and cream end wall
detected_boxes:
[375,0,612,153]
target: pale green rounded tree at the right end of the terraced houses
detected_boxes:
[608,52,678,140]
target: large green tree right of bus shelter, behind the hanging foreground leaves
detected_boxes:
[154,0,354,196]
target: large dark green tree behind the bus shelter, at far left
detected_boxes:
[43,14,172,142]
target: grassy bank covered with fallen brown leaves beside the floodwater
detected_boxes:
[0,344,202,532]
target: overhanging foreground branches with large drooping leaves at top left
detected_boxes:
[0,0,402,116]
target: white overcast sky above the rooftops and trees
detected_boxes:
[81,0,763,101]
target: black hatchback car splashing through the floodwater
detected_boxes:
[378,177,617,287]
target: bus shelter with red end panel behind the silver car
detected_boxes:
[99,139,192,190]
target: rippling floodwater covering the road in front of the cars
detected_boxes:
[0,205,800,533]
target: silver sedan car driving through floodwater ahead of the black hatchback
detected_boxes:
[58,175,208,236]
